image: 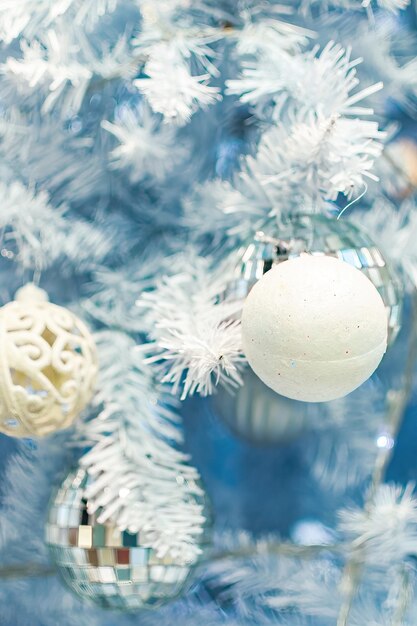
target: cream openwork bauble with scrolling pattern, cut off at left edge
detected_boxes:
[0,284,97,437]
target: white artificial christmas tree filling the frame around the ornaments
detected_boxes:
[0,0,417,626]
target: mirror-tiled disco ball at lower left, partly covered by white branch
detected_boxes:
[46,469,209,611]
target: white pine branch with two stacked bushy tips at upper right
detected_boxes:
[216,42,384,221]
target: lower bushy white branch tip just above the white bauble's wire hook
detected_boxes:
[245,114,384,215]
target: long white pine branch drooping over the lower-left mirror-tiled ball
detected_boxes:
[79,331,205,563]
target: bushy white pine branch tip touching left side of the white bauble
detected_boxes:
[138,251,244,399]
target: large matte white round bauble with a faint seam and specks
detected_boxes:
[242,254,388,402]
